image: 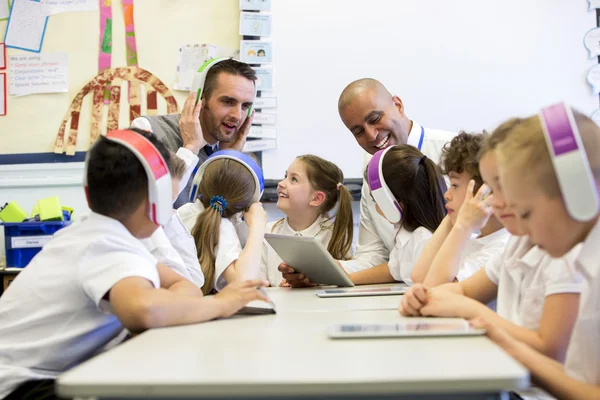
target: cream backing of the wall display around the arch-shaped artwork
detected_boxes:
[0,0,241,161]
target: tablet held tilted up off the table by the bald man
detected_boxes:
[265,233,354,286]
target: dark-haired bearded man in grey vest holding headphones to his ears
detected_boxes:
[131,59,256,208]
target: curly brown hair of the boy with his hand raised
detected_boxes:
[440,132,486,192]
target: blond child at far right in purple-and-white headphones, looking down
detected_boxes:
[474,104,600,399]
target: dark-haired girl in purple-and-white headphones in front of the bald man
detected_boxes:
[350,144,446,284]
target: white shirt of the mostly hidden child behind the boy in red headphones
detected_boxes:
[142,213,204,287]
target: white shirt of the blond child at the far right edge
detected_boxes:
[565,219,600,386]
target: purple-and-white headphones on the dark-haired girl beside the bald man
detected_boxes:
[367,146,402,224]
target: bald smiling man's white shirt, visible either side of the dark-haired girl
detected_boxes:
[342,121,456,273]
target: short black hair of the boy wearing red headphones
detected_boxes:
[86,128,171,221]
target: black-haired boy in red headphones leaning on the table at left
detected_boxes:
[0,131,267,400]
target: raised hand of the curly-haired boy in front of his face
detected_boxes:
[455,180,493,232]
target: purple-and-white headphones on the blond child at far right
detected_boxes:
[539,103,600,222]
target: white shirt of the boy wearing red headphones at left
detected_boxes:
[0,213,160,398]
